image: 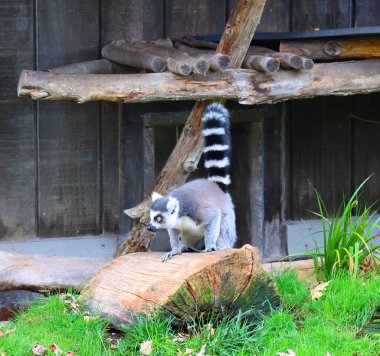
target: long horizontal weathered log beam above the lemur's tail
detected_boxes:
[18,59,380,105]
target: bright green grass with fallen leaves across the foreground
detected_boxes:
[0,272,380,356]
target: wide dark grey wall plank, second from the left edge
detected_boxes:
[37,0,101,237]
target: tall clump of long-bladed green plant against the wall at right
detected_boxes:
[303,177,380,280]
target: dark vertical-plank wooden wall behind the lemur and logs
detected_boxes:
[0,0,380,255]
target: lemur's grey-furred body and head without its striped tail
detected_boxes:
[151,179,237,261]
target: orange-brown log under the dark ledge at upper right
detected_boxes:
[280,36,380,61]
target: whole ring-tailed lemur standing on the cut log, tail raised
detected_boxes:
[147,103,237,261]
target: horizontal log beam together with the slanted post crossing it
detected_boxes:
[18,0,380,255]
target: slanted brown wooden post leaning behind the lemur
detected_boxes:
[116,0,265,256]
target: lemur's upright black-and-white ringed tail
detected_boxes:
[202,103,231,192]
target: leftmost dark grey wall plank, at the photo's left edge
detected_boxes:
[0,0,37,241]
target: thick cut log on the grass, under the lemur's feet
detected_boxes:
[82,245,280,327]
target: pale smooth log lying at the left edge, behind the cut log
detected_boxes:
[0,251,109,292]
